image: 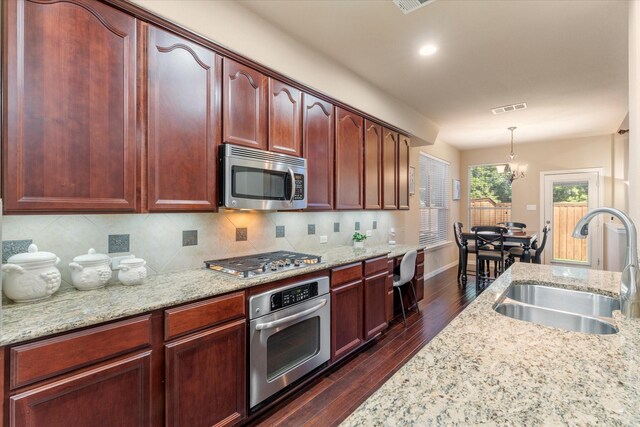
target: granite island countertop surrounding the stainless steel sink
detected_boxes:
[343,263,640,426]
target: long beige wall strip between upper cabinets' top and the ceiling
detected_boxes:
[133,0,438,143]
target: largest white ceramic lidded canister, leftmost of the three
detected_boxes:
[2,244,61,302]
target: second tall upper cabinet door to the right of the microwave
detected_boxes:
[335,107,364,209]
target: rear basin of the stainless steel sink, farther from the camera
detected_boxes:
[506,284,620,317]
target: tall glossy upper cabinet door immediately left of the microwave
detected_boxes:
[147,27,221,211]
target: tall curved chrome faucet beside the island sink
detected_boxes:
[573,208,640,319]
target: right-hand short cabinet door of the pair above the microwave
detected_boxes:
[269,78,302,156]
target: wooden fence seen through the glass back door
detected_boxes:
[552,202,589,261]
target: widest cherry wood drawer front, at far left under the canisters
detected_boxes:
[10,315,151,389]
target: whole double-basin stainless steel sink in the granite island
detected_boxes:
[494,283,620,335]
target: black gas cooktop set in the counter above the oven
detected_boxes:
[204,251,322,277]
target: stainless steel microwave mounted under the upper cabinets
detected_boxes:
[220,144,307,210]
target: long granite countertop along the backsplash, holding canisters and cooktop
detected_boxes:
[0,245,418,346]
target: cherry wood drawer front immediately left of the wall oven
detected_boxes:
[164,292,245,340]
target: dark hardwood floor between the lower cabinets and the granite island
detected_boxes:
[251,267,482,426]
